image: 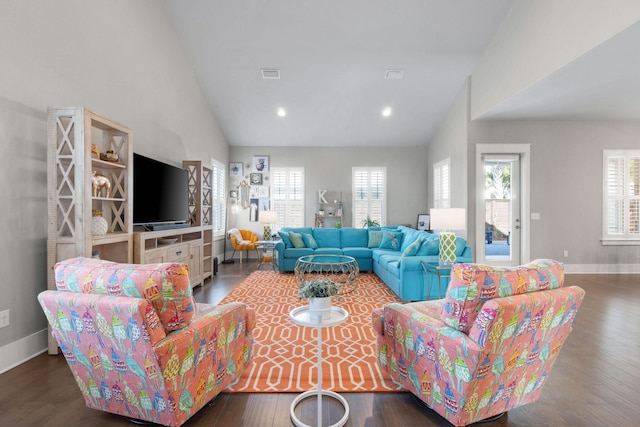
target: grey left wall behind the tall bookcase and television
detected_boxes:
[0,0,228,372]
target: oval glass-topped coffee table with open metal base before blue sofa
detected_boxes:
[293,254,360,295]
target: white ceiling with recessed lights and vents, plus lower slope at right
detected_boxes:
[163,0,640,146]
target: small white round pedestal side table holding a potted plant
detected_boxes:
[289,306,349,427]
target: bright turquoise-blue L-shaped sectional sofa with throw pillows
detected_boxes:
[276,226,472,301]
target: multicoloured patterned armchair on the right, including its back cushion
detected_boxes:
[373,260,584,426]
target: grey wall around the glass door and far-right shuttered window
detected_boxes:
[469,121,640,272]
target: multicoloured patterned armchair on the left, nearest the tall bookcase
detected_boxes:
[38,258,255,426]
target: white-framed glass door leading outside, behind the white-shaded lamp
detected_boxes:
[476,144,529,266]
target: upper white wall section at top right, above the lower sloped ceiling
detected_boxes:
[470,0,640,120]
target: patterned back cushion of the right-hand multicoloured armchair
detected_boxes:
[441,259,564,333]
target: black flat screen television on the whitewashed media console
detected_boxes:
[133,153,189,226]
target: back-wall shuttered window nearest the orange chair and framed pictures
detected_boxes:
[270,167,304,229]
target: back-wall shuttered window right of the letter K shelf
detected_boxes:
[352,167,387,227]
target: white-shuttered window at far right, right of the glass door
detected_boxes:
[602,150,640,244]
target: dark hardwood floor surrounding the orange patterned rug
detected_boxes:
[0,261,640,427]
